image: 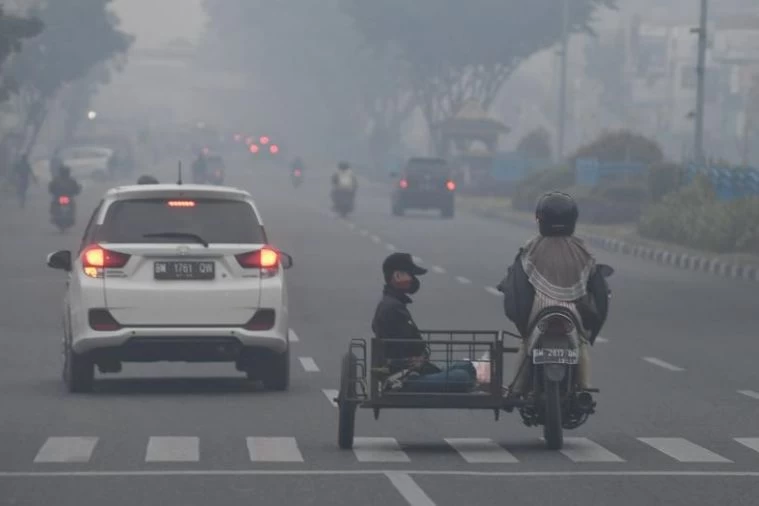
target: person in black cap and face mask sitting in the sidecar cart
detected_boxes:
[372,253,477,391]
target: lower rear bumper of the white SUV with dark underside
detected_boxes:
[72,325,288,362]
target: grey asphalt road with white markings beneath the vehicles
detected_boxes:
[0,158,759,506]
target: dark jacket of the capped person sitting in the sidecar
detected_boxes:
[372,285,427,360]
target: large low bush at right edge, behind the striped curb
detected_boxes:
[638,176,759,253]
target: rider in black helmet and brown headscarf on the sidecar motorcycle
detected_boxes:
[498,192,609,396]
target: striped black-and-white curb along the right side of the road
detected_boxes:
[470,209,759,282]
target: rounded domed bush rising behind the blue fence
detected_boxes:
[570,130,664,165]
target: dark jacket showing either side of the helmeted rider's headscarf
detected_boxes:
[498,248,609,344]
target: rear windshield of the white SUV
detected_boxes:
[94,198,266,244]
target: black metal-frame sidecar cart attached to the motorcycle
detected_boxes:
[335,330,525,449]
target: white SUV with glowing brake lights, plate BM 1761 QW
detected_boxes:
[47,184,292,392]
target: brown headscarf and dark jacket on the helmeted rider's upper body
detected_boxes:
[499,237,609,343]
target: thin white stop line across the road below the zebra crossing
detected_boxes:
[7,469,759,478]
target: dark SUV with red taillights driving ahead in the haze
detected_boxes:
[393,158,456,218]
